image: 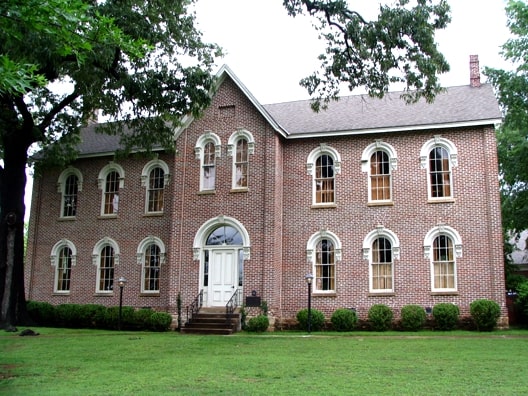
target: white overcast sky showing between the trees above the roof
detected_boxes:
[26,0,509,219]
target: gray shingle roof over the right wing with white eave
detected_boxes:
[263,84,502,137]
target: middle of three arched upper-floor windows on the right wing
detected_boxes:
[361,140,398,204]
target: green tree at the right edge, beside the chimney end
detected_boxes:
[484,1,528,236]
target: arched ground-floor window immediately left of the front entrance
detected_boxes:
[137,237,165,293]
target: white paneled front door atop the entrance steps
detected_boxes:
[207,249,238,307]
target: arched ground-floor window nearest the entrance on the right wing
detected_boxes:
[306,230,341,293]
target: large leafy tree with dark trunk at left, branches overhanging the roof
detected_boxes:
[0,0,449,329]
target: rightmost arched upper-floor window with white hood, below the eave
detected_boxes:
[420,136,458,201]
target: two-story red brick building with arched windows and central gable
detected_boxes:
[26,59,507,320]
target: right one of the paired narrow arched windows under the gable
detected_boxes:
[227,129,255,190]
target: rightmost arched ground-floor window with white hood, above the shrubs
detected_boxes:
[424,225,462,292]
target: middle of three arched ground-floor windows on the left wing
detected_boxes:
[92,238,119,293]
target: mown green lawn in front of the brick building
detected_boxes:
[0,328,528,396]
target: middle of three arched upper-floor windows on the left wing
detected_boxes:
[97,162,125,216]
